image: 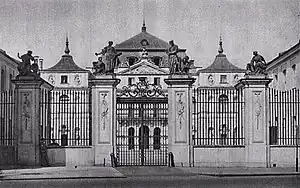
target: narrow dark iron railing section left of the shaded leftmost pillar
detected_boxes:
[0,91,15,146]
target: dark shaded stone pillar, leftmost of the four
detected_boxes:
[12,76,52,166]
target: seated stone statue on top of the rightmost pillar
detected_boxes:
[246,51,267,75]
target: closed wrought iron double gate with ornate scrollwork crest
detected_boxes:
[116,81,168,166]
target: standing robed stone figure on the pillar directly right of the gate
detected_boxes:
[166,40,180,74]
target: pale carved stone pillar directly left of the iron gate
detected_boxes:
[89,75,120,165]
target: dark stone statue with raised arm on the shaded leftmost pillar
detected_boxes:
[18,50,39,77]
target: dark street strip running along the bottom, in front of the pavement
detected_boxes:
[0,176,300,188]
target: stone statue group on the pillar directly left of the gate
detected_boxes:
[95,41,122,74]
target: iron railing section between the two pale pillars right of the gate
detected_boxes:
[192,88,245,147]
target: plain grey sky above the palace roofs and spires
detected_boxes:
[0,0,300,68]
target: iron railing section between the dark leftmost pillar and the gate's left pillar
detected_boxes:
[40,89,92,146]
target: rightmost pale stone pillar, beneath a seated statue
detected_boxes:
[235,75,272,167]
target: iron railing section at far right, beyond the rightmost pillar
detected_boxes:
[268,88,300,146]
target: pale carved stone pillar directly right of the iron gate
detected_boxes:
[165,75,195,166]
